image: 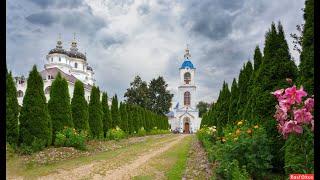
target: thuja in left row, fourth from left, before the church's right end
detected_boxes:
[71,81,90,133]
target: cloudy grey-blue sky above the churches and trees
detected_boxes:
[6,0,304,102]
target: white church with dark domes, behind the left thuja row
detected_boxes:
[15,35,99,106]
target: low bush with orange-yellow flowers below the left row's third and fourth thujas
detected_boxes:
[54,127,87,150]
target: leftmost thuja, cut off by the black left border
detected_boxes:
[6,72,19,145]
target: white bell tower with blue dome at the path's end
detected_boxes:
[167,48,201,133]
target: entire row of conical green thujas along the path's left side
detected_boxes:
[6,66,168,151]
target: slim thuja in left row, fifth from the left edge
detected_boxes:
[89,86,103,138]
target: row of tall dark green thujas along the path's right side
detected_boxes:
[201,0,314,172]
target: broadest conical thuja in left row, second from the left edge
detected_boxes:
[19,66,52,151]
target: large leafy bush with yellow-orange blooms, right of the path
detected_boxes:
[197,120,272,179]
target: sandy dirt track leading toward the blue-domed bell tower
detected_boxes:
[40,135,188,180]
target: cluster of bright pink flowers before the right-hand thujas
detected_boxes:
[272,85,314,138]
